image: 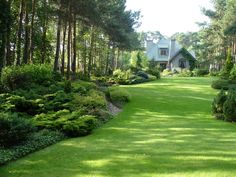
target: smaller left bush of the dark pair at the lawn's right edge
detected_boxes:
[212,90,227,119]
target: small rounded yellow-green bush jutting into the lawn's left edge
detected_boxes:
[109,87,131,107]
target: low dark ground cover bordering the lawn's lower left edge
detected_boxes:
[0,130,65,165]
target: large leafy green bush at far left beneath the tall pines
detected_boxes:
[1,65,53,90]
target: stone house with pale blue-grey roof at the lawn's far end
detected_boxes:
[146,38,196,71]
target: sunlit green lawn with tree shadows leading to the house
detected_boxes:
[0,78,236,177]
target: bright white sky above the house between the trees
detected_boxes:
[126,0,212,36]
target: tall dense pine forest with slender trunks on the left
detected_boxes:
[0,0,142,78]
